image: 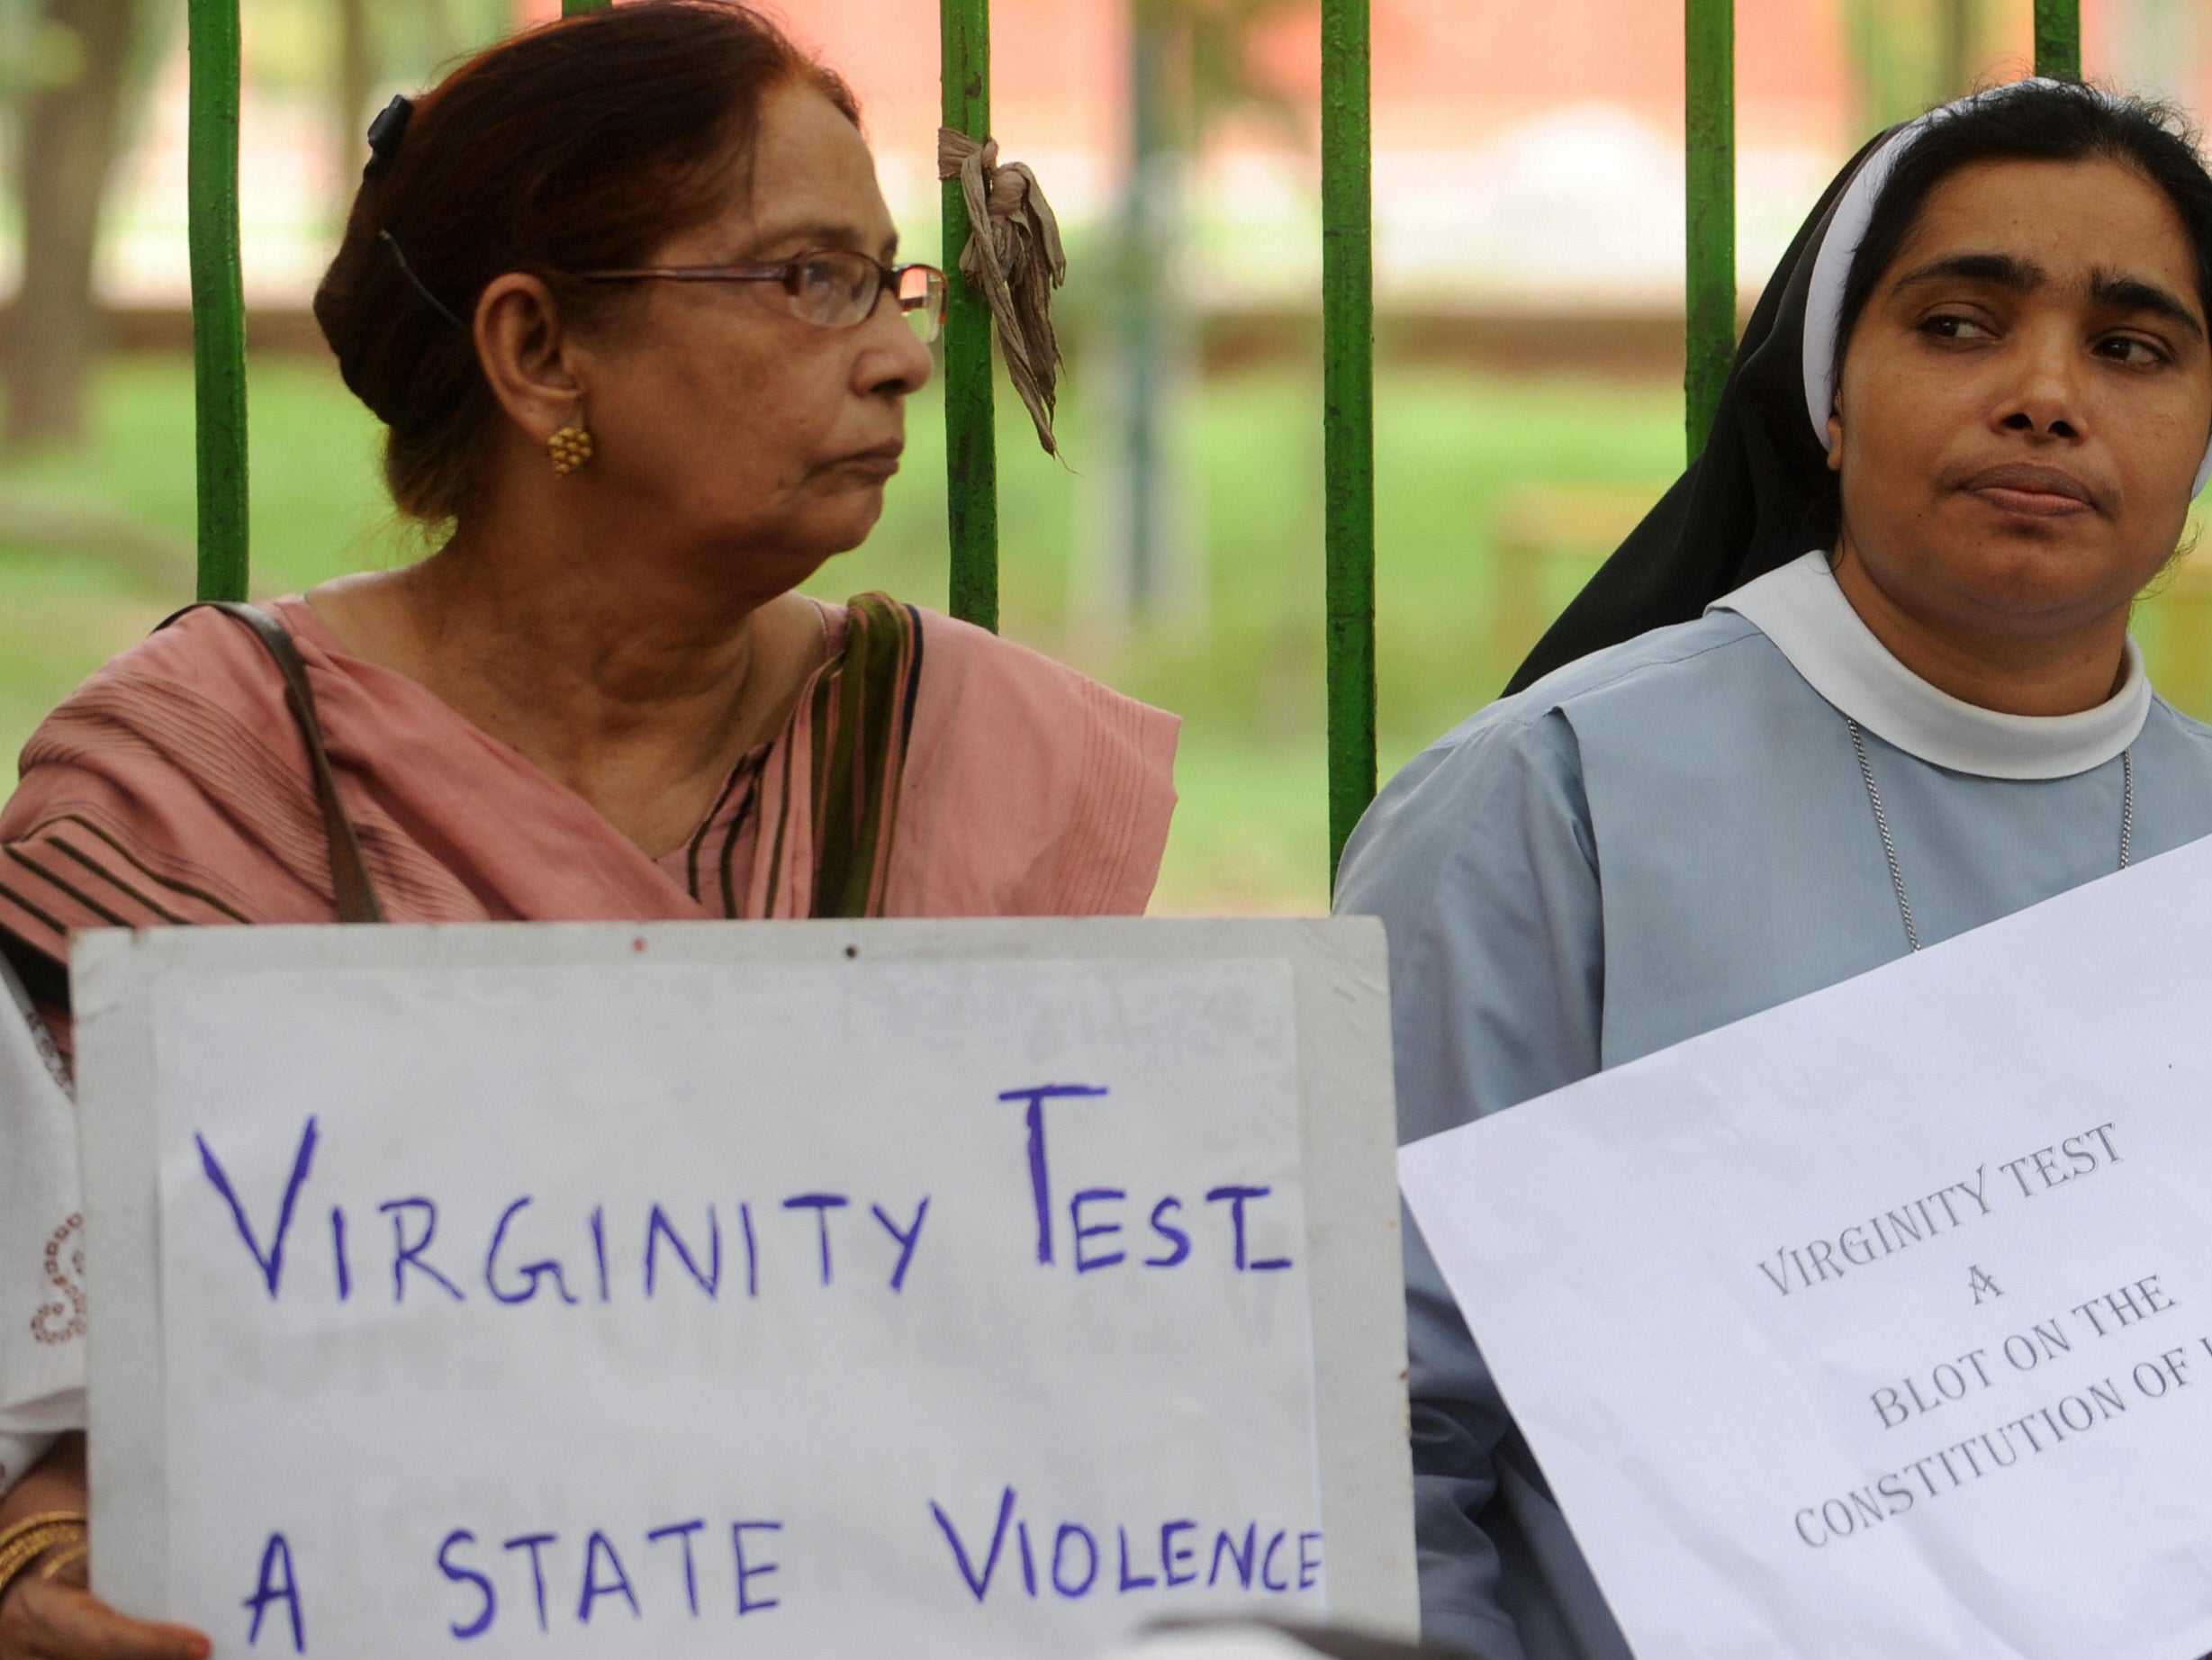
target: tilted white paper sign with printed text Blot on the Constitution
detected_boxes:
[1400,843,2212,1660]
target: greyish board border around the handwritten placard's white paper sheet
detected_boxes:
[71,917,1420,1637]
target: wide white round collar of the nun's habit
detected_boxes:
[1708,550,2150,778]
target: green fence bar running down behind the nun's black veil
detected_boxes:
[1681,0,1737,460]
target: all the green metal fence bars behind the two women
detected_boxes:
[188,0,2081,897]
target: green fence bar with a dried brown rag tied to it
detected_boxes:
[938,0,998,630]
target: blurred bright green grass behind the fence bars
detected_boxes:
[13,356,2212,911]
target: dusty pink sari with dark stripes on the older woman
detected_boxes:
[0,595,1177,1001]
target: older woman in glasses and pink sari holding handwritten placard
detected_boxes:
[0,0,1175,1660]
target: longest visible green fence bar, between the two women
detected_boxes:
[1321,0,1376,889]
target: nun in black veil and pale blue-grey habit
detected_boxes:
[1338,82,2212,1660]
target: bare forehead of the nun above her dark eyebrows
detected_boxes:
[1887,157,2197,296]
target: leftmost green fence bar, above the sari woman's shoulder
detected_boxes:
[185,0,246,599]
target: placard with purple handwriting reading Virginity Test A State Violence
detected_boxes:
[77,924,1412,1660]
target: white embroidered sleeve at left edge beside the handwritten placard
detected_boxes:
[0,955,84,1494]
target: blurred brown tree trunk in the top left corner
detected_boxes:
[0,0,144,448]
